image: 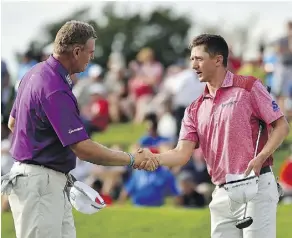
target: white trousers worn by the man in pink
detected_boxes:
[209,172,279,238]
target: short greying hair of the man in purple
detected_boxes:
[54,20,97,54]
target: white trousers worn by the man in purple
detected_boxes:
[8,162,76,238]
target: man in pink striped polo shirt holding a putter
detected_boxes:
[139,34,289,238]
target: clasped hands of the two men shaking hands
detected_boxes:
[133,148,160,171]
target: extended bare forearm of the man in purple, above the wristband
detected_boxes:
[71,140,130,166]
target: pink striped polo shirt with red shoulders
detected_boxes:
[179,71,283,185]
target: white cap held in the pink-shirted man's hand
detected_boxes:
[224,176,259,203]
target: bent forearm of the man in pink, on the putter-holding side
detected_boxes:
[258,118,289,161]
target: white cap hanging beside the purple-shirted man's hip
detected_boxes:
[69,181,106,214]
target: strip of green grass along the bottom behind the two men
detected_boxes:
[1,205,292,238]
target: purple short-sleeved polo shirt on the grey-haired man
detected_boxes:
[10,56,89,173]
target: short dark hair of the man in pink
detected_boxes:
[189,34,229,67]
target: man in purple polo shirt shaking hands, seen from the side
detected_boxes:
[2,21,158,238]
